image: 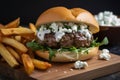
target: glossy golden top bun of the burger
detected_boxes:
[36,7,99,33]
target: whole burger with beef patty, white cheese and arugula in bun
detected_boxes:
[27,7,108,62]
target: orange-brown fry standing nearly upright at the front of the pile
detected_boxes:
[22,54,34,74]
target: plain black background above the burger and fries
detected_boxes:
[0,0,120,25]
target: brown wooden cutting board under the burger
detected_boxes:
[30,54,120,80]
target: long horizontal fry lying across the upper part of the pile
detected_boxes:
[0,27,34,36]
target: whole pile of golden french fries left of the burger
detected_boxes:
[0,18,51,74]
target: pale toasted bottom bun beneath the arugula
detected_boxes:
[36,47,99,62]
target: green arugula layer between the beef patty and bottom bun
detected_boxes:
[26,37,109,60]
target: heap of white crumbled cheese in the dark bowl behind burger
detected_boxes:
[95,11,120,26]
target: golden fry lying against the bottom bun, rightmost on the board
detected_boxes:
[32,59,52,70]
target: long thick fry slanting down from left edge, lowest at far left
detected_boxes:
[0,43,19,67]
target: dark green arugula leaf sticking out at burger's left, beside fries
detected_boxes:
[26,41,44,51]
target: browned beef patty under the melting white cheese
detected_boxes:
[38,32,93,48]
